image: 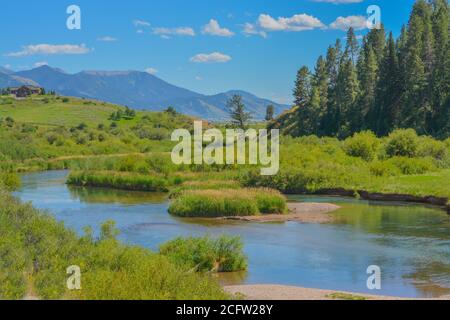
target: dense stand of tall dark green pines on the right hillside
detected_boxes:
[280,0,450,138]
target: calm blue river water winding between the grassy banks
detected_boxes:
[16,171,450,297]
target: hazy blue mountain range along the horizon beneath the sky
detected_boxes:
[0,65,289,120]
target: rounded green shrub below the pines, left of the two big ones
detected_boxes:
[344,131,380,161]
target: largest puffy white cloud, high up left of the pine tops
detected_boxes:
[243,13,325,37]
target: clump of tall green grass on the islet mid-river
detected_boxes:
[169,189,287,217]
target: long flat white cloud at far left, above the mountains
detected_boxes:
[6,44,91,57]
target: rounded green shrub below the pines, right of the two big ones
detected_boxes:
[386,129,419,158]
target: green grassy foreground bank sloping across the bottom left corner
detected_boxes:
[0,191,229,300]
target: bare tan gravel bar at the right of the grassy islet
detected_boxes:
[221,203,340,223]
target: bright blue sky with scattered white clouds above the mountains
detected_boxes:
[0,0,414,103]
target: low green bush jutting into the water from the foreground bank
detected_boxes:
[160,236,247,272]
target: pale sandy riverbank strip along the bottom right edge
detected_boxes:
[224,285,450,301]
